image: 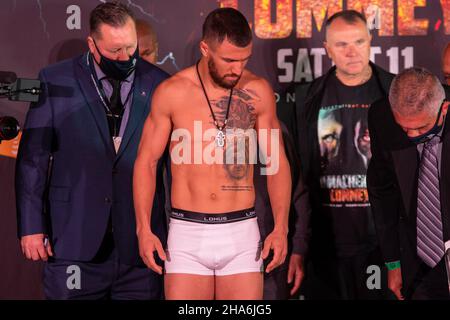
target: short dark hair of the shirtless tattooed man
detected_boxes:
[202,8,252,48]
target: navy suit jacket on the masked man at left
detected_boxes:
[16,54,168,265]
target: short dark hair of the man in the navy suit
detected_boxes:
[89,1,135,36]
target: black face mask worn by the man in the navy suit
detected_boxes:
[94,41,139,81]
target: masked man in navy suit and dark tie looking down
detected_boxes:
[16,3,168,299]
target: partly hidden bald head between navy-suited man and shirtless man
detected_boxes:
[136,20,158,64]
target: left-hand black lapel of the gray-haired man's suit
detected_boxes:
[391,145,418,219]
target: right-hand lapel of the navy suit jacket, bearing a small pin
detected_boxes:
[116,64,153,161]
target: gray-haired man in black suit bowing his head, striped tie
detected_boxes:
[368,68,450,299]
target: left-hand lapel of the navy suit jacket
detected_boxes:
[75,54,114,156]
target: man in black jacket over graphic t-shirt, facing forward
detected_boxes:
[290,10,393,299]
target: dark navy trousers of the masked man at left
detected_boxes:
[43,233,163,300]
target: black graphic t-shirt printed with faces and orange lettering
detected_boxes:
[317,75,382,257]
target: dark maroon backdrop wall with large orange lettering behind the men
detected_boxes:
[0,0,450,299]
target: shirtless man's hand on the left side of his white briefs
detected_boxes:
[137,231,166,274]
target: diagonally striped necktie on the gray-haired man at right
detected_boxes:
[417,137,444,268]
